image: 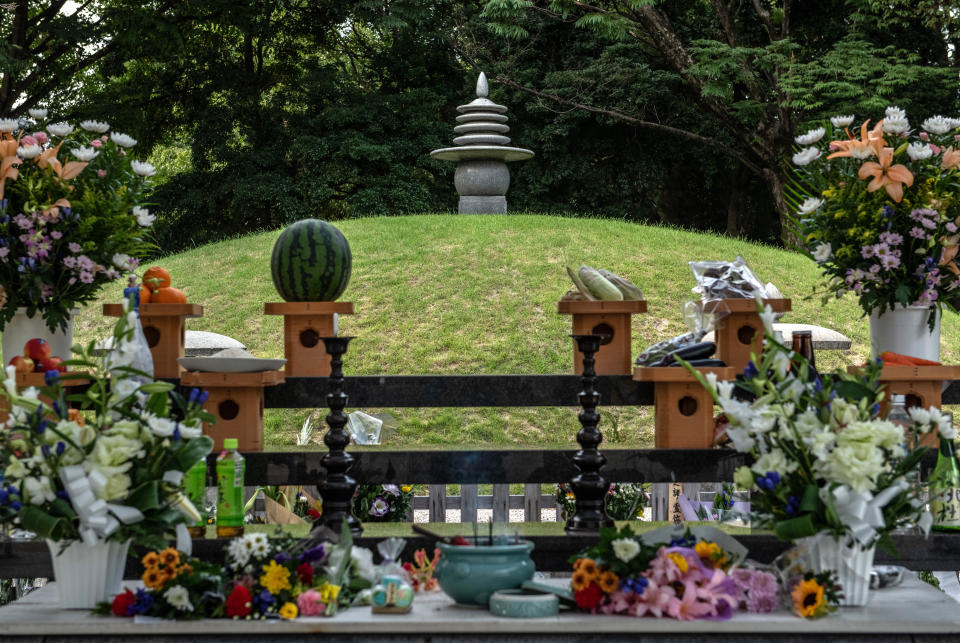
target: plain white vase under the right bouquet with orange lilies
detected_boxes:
[870,306,940,362]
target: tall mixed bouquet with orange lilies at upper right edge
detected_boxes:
[791,107,960,328]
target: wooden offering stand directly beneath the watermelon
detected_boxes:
[263,301,353,377]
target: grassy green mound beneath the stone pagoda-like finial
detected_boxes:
[69,214,960,448]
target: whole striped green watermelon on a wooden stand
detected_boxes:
[270,219,351,301]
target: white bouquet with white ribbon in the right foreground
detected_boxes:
[687,303,944,603]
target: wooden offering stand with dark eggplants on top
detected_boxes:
[633,366,736,449]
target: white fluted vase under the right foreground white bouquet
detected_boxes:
[797,533,876,607]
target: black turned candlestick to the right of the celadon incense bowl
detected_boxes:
[565,335,613,534]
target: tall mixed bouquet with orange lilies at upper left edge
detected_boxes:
[0,110,155,331]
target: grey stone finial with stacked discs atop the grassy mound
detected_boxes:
[430,72,533,214]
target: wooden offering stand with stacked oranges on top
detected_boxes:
[103,304,203,378]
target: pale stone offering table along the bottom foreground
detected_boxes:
[0,573,960,643]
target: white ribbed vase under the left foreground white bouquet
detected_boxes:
[47,540,130,609]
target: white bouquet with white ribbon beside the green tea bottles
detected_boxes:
[0,300,214,600]
